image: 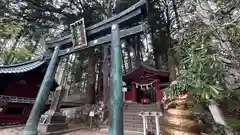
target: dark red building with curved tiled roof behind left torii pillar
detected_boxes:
[0,58,58,125]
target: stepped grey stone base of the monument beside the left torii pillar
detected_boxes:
[38,113,68,135]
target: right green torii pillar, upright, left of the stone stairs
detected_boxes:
[108,24,124,135]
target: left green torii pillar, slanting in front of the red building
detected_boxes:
[20,46,61,135]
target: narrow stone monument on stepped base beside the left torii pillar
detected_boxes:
[38,86,68,134]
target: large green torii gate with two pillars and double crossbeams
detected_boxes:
[20,0,147,135]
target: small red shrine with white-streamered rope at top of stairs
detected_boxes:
[123,63,169,104]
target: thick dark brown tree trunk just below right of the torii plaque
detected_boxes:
[87,49,96,104]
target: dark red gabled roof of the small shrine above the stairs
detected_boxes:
[123,63,169,82]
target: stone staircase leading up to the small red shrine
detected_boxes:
[123,103,162,132]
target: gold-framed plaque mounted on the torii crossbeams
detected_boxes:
[70,18,87,49]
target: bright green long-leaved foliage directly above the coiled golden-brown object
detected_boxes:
[167,23,228,101]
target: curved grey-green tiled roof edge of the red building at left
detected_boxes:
[0,58,45,74]
